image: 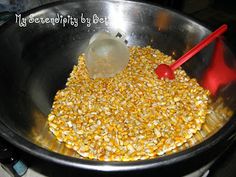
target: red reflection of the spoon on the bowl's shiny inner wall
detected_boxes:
[202,38,236,95]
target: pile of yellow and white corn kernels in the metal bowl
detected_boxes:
[48,47,210,161]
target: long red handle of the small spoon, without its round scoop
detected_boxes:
[170,24,228,71]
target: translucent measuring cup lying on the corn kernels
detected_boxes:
[85,32,129,79]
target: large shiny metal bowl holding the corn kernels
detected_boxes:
[0,0,236,176]
